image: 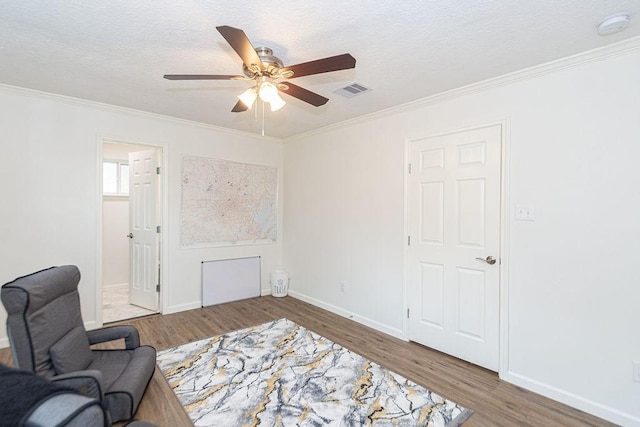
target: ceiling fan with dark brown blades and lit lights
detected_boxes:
[164,25,356,113]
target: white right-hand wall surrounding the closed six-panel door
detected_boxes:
[284,49,640,425]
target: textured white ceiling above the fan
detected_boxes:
[0,0,640,137]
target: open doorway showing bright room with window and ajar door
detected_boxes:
[102,140,162,323]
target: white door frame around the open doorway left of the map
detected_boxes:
[95,135,169,327]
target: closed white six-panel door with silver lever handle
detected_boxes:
[408,126,502,371]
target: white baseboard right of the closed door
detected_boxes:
[500,372,640,427]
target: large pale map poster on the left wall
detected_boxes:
[180,156,278,246]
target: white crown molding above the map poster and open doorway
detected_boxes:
[0,83,282,144]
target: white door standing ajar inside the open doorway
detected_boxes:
[129,150,160,311]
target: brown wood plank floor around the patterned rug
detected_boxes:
[0,297,613,427]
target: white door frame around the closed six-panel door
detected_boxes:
[402,118,510,378]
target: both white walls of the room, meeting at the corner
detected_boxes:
[0,42,640,425]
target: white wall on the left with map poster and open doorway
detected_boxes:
[0,86,282,336]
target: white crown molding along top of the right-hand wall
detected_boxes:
[283,36,640,143]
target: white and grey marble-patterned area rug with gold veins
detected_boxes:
[158,319,471,426]
